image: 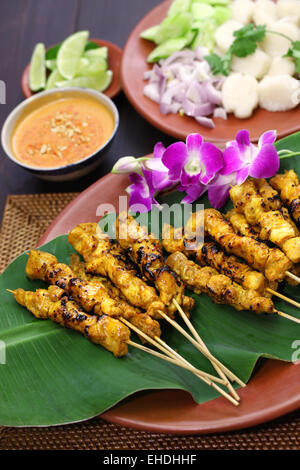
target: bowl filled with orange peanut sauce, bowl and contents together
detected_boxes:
[1,88,119,181]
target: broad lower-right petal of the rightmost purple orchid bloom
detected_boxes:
[249,144,279,178]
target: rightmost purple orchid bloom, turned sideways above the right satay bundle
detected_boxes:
[220,129,279,184]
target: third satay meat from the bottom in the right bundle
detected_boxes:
[204,209,292,282]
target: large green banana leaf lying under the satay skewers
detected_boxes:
[0,134,300,426]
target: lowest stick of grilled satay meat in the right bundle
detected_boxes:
[167,252,274,313]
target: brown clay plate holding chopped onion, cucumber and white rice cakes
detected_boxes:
[121,0,300,145]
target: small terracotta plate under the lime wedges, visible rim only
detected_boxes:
[21,39,122,98]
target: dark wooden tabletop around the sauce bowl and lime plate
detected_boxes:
[0,0,172,217]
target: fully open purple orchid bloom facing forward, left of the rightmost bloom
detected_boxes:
[162,134,223,188]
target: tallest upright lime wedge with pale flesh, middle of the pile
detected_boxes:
[57,31,89,80]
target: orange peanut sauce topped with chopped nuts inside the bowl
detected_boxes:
[12,97,114,168]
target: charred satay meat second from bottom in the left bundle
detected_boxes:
[25,250,161,338]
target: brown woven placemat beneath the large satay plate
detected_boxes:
[0,193,300,450]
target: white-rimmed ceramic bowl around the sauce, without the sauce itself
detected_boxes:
[1,87,119,181]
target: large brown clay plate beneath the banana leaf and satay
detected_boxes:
[39,174,300,434]
